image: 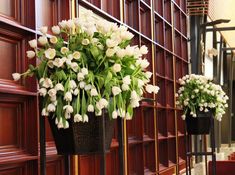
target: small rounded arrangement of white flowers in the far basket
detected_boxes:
[176,74,228,121]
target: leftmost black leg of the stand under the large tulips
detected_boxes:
[39,105,46,175]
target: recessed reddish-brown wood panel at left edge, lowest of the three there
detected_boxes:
[0,103,20,149]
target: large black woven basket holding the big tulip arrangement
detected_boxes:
[48,113,114,155]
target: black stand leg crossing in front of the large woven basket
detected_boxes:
[100,111,106,175]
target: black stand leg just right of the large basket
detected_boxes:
[118,117,125,175]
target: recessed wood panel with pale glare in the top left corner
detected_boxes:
[0,0,19,18]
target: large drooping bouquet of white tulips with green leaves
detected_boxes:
[13,11,159,128]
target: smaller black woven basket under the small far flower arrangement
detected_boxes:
[186,111,213,135]
